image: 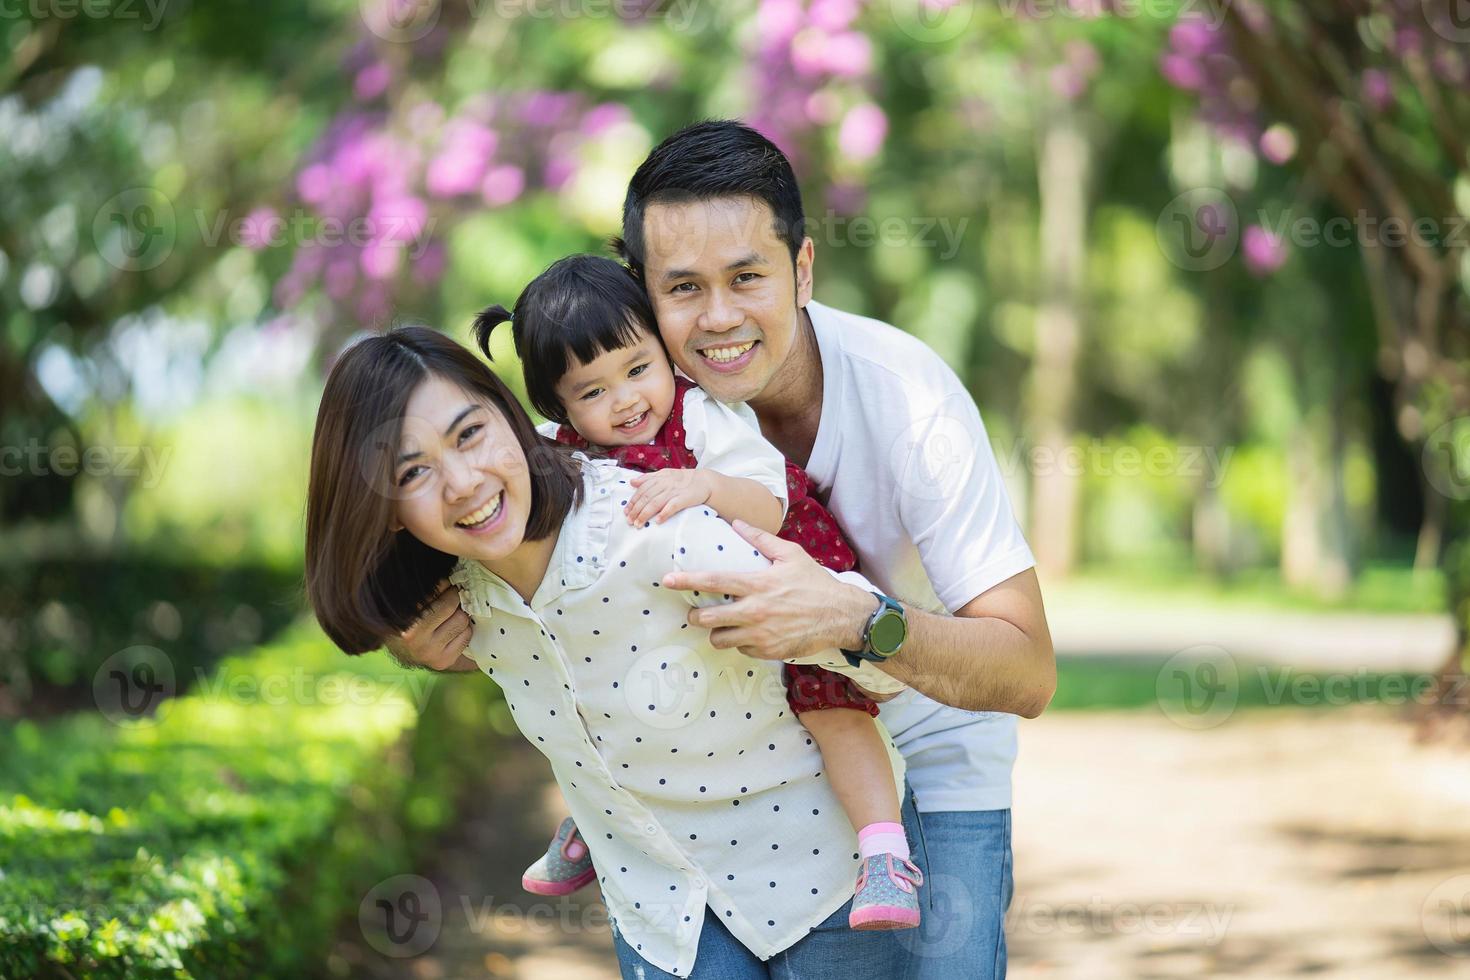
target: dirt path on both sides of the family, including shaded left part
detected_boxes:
[334,707,1470,980]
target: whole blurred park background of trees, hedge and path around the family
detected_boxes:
[0,0,1470,977]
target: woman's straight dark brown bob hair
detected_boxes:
[306,326,582,654]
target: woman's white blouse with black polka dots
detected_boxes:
[451,457,904,976]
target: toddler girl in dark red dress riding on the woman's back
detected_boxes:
[475,256,923,929]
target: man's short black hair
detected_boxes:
[613,119,806,276]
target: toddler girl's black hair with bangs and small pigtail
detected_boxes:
[473,256,657,425]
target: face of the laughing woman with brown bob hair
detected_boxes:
[391,375,531,561]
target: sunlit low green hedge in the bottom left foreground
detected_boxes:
[0,626,497,979]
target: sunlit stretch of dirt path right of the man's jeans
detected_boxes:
[1007,707,1470,980]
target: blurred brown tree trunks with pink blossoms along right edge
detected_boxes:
[1164,0,1470,669]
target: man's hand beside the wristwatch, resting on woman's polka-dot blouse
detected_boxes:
[663,520,875,660]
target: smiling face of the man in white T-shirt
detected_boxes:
[642,197,811,403]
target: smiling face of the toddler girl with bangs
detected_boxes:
[556,328,673,447]
